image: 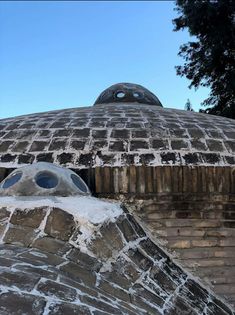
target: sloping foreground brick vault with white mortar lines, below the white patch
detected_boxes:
[0,202,234,315]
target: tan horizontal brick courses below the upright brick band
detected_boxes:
[130,194,235,305]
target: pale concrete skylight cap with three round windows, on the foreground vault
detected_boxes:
[0,162,90,197]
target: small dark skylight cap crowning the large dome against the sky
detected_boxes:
[94,83,162,107]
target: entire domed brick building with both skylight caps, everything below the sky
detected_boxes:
[0,83,235,315]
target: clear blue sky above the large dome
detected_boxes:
[0,1,208,118]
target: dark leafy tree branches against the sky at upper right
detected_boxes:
[173,0,235,118]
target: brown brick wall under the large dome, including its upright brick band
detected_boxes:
[80,166,235,303]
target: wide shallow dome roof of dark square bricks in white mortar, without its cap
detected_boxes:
[0,103,235,168]
